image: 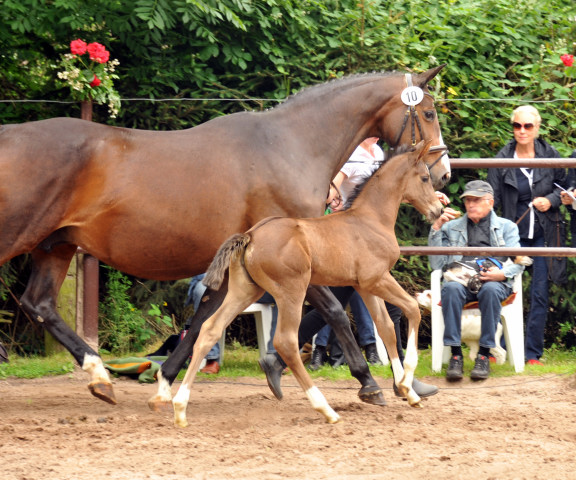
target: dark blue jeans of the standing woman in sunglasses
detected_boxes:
[520,236,548,361]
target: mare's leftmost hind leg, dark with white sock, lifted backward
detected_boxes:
[21,245,116,405]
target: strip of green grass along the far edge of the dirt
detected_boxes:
[0,343,576,381]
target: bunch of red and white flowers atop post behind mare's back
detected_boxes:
[58,39,120,118]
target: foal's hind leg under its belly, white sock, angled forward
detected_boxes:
[274,296,340,423]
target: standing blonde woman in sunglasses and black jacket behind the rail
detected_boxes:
[488,105,566,365]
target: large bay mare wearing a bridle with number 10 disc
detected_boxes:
[0,67,450,407]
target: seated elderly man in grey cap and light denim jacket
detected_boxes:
[428,180,524,381]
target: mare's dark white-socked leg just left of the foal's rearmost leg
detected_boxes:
[148,274,228,412]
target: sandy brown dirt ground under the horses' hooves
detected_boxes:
[0,372,576,480]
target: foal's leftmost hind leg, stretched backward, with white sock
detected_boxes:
[172,263,264,427]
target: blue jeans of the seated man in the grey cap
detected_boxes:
[441,282,512,348]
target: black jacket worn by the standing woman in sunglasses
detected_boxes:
[488,138,566,283]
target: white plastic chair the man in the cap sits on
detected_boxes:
[430,270,524,373]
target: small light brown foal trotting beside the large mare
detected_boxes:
[173,141,442,427]
